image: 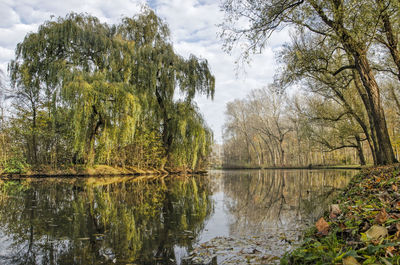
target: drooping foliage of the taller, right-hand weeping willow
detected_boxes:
[118,10,215,167]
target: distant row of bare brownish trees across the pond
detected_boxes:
[222,86,400,167]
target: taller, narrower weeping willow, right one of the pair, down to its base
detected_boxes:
[117,9,215,168]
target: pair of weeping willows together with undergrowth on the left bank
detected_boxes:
[9,8,215,168]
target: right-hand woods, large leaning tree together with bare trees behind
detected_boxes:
[221,0,400,167]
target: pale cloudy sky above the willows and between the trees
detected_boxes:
[0,0,289,143]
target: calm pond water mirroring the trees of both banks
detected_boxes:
[0,170,355,264]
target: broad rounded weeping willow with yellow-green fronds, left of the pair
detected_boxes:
[10,14,140,165]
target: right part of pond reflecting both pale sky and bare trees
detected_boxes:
[195,170,356,258]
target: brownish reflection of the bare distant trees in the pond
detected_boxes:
[223,170,352,234]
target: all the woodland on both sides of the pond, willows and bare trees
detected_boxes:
[0,0,400,173]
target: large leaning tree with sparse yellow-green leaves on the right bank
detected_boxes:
[221,0,400,164]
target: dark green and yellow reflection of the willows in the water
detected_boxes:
[0,177,211,264]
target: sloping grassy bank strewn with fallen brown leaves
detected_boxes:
[281,164,400,265]
